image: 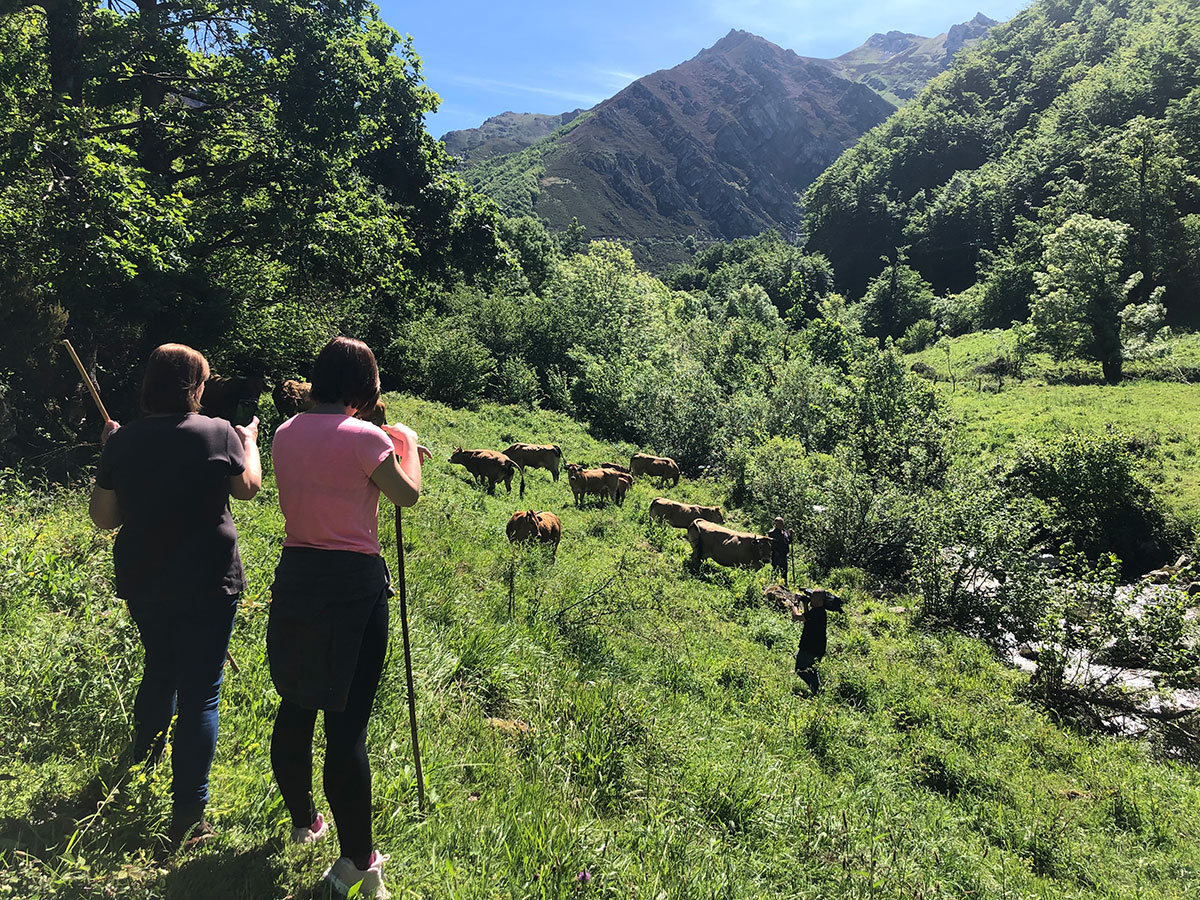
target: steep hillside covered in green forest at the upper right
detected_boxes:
[804,0,1200,328]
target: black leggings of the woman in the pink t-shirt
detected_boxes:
[271,600,388,869]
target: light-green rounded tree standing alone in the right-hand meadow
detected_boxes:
[1030,212,1160,384]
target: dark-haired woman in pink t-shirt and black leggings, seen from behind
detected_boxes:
[266,337,428,896]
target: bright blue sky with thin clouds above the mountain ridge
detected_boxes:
[377,0,1028,137]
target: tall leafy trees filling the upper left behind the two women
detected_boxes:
[0,0,509,472]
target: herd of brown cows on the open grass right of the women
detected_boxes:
[450,444,772,568]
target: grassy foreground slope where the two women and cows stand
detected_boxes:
[0,397,1200,900]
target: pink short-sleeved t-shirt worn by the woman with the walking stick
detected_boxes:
[271,413,392,554]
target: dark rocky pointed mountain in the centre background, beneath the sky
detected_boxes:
[467,31,893,260]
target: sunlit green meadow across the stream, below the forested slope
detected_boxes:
[907,330,1200,514]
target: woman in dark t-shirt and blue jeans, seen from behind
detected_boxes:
[89,344,263,842]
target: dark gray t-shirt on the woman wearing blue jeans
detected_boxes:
[96,413,246,601]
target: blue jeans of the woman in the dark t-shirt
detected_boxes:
[130,595,238,806]
